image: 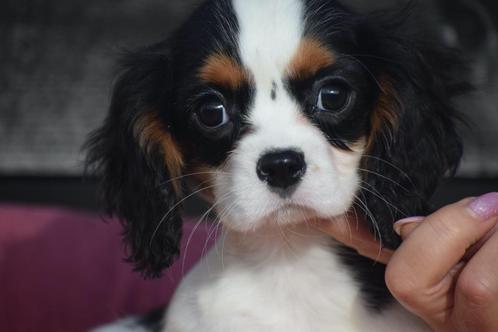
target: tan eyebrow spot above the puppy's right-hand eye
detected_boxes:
[287,38,335,79]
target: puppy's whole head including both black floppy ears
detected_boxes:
[90,0,461,275]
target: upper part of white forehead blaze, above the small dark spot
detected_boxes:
[233,0,303,92]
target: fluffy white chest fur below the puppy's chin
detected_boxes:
[165,228,427,332]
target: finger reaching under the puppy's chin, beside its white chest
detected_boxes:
[315,216,393,264]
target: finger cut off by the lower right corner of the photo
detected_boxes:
[452,232,498,331]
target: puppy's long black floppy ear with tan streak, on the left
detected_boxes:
[87,44,183,277]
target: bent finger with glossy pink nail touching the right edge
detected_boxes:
[386,193,498,301]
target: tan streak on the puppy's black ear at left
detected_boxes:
[135,113,184,192]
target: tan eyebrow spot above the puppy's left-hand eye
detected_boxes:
[198,53,249,90]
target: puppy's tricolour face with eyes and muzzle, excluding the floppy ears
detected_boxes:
[172,0,379,231]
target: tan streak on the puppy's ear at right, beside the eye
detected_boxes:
[366,77,402,151]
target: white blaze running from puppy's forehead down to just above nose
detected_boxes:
[233,0,304,144]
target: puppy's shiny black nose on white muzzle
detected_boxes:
[257,150,306,189]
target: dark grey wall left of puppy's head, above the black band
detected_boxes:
[0,0,200,175]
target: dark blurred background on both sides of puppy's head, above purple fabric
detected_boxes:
[0,0,498,214]
